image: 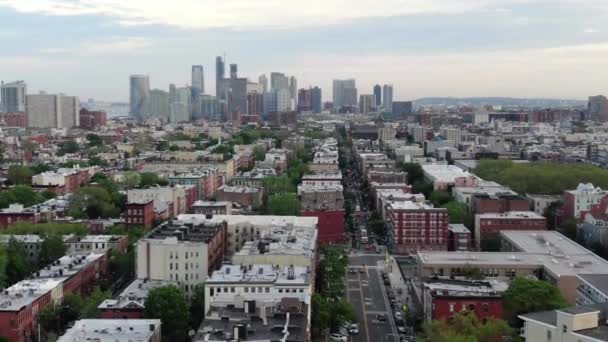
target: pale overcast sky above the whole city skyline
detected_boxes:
[0,0,608,101]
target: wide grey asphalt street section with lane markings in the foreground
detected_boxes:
[347,255,399,342]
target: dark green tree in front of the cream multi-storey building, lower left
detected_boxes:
[144,285,190,341]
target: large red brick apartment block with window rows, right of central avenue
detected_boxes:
[386,201,448,254]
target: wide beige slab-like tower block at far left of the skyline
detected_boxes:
[26,94,80,128]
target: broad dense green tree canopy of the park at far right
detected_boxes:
[474,160,608,194]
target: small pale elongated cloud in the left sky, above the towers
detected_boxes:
[40,37,152,55]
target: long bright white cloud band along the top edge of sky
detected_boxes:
[0,0,540,29]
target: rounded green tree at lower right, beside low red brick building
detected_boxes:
[503,277,568,319]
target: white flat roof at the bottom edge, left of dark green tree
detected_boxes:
[57,319,161,342]
